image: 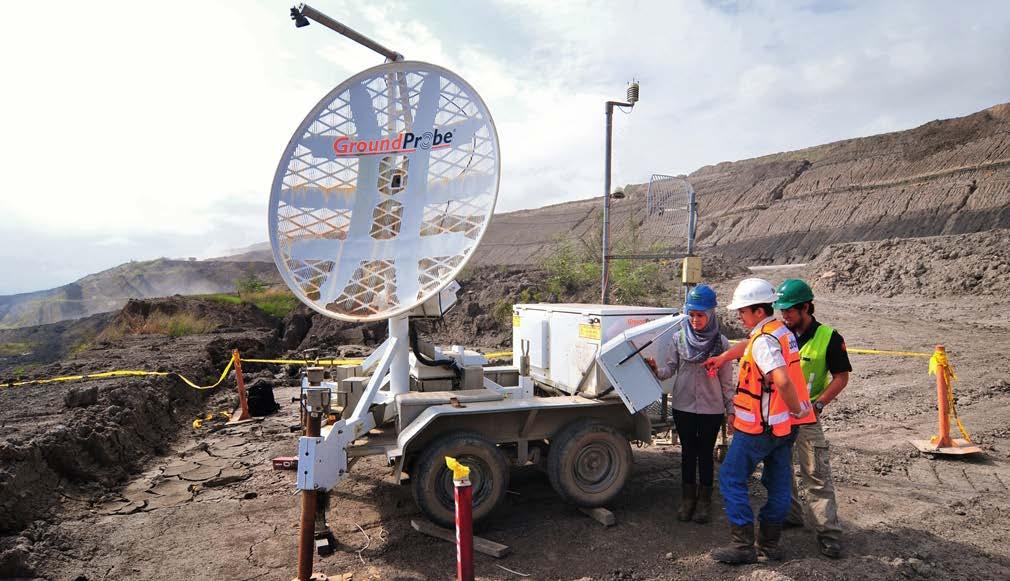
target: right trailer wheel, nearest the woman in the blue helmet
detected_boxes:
[547,419,631,507]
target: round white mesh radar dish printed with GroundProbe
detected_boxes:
[269,62,501,321]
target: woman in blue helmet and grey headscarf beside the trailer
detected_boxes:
[645,285,736,522]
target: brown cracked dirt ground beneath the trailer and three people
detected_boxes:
[0,260,1010,580]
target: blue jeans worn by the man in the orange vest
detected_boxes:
[719,429,796,526]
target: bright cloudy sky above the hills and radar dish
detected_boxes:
[0,0,1010,294]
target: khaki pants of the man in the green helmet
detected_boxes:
[789,421,841,541]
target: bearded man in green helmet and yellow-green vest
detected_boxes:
[775,279,852,559]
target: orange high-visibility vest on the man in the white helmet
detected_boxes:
[733,319,817,437]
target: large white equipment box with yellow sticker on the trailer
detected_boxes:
[512,303,677,396]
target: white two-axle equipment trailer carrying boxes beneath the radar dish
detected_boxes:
[298,301,683,526]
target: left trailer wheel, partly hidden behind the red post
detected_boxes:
[410,431,508,528]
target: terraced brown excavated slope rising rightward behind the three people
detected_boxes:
[475,104,1010,265]
